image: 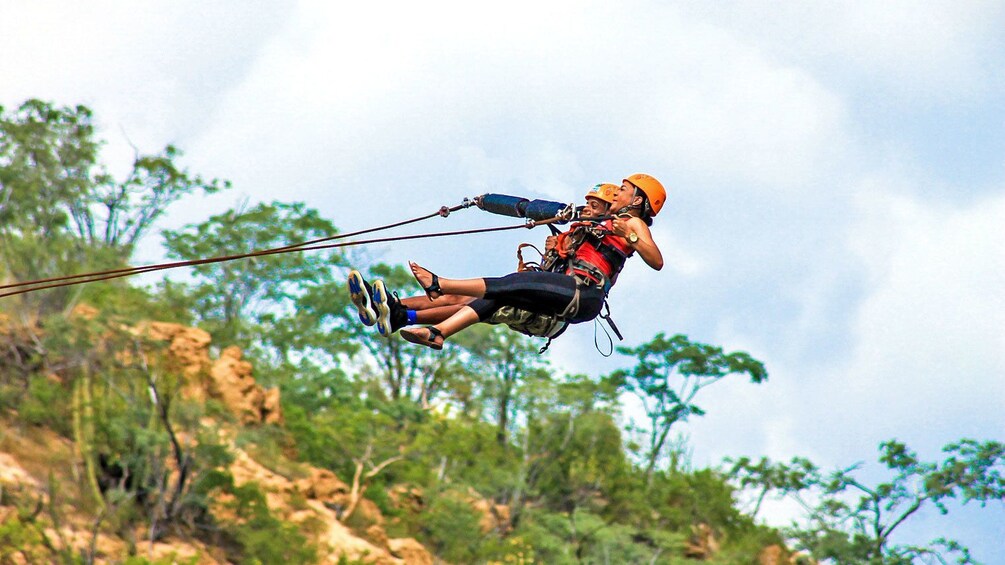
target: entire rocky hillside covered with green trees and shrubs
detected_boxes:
[0,101,1005,564]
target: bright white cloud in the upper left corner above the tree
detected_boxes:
[0,1,288,174]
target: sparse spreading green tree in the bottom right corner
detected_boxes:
[731,439,1005,564]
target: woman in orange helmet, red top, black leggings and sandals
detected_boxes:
[387,174,666,350]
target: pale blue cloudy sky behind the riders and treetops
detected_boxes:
[0,0,1005,563]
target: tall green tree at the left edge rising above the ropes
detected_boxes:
[0,100,228,325]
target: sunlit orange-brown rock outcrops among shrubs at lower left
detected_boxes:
[0,322,440,564]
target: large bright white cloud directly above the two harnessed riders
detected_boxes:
[184,0,846,199]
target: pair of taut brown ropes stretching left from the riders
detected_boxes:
[0,205,565,299]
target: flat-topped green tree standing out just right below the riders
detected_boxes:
[608,334,768,481]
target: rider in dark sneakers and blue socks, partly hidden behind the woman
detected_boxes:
[349,183,618,337]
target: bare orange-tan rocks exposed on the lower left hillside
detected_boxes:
[0,319,433,565]
